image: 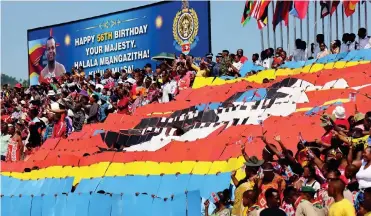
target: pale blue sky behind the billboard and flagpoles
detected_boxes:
[1,1,371,79]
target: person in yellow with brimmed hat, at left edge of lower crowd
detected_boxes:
[231,156,264,215]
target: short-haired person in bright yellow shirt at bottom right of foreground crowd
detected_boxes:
[328,179,356,216]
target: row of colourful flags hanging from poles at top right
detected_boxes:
[241,0,365,30]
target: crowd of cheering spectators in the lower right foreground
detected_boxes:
[204,106,371,216]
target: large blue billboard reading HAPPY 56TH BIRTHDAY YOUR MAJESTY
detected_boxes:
[27,1,211,85]
